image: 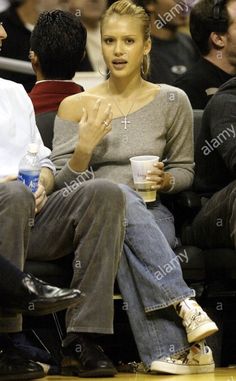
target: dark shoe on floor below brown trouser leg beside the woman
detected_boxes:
[61,333,117,377]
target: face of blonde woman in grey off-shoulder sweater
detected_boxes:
[102,15,151,77]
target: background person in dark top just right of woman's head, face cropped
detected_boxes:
[135,0,199,85]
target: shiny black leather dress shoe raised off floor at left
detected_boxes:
[1,274,81,316]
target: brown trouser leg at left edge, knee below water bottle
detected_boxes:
[0,181,35,332]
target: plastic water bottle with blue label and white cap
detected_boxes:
[18,143,41,192]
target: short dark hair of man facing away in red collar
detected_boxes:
[30,10,87,79]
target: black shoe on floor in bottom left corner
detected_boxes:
[0,348,45,381]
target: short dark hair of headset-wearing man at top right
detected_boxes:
[190,0,231,55]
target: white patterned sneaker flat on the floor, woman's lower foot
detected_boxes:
[150,341,215,374]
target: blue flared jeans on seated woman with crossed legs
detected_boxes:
[118,184,195,366]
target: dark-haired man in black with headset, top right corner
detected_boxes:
[174,0,236,109]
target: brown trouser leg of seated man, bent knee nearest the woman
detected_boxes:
[28,180,124,333]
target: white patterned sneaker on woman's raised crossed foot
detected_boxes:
[175,299,218,343]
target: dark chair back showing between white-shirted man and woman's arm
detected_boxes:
[36,111,57,149]
